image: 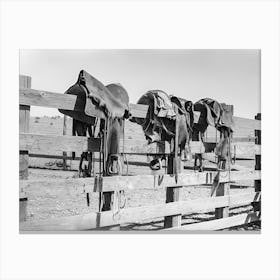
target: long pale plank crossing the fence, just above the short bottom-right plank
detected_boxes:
[20,193,260,231]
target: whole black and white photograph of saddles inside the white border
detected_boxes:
[19,49,261,233]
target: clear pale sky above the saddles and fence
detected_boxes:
[20,49,261,118]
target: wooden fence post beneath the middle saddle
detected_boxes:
[164,114,182,228]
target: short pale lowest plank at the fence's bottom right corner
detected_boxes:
[166,212,261,231]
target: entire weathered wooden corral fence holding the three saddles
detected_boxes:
[19,76,261,231]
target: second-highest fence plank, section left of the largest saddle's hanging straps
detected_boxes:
[19,133,101,154]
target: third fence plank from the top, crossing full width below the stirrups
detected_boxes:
[19,170,261,199]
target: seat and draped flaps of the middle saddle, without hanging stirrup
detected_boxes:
[131,90,193,143]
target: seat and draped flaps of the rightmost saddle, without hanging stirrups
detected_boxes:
[194,98,235,132]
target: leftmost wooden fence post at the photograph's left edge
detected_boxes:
[19,76,31,222]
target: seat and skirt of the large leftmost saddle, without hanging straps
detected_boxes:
[59,70,129,124]
